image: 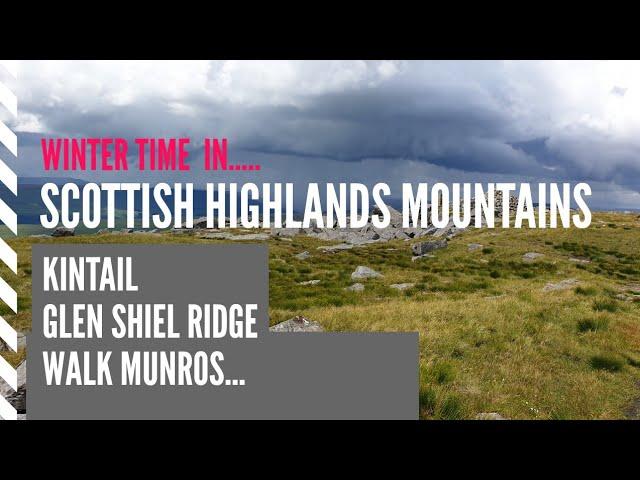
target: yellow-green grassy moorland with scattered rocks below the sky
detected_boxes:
[0,214,640,419]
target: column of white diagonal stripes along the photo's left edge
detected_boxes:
[0,64,18,420]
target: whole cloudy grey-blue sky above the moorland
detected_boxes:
[0,61,640,208]
